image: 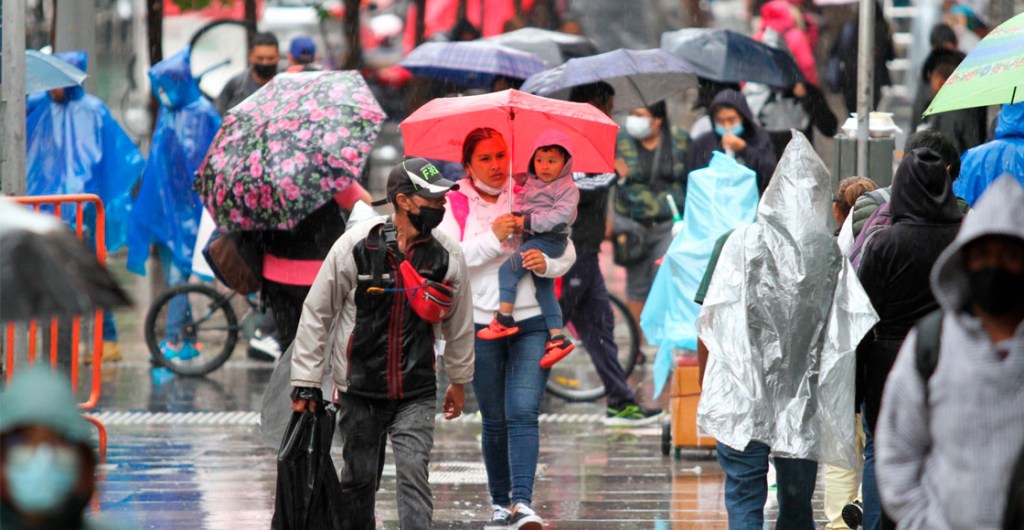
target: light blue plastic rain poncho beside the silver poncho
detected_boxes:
[640,151,758,396]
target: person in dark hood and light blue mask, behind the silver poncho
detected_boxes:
[686,90,777,193]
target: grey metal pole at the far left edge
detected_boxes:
[0,0,26,195]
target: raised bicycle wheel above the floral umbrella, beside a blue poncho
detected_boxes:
[188,18,258,101]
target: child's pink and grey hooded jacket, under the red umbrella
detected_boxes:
[512,129,580,234]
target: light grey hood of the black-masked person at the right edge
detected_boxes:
[931,175,1024,313]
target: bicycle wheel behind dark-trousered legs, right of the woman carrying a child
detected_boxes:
[546,295,641,401]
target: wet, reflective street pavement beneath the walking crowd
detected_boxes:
[58,250,839,530]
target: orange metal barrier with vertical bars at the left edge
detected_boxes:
[5,193,106,460]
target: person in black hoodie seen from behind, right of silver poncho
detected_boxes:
[857,148,964,529]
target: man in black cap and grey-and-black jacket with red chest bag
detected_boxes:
[292,159,473,530]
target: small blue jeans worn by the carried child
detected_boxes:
[498,233,568,329]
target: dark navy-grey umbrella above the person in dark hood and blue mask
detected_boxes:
[662,29,804,88]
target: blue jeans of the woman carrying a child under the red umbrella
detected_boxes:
[473,316,548,506]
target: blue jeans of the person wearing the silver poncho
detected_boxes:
[718,441,818,530]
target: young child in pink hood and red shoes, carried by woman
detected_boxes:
[476,130,580,369]
